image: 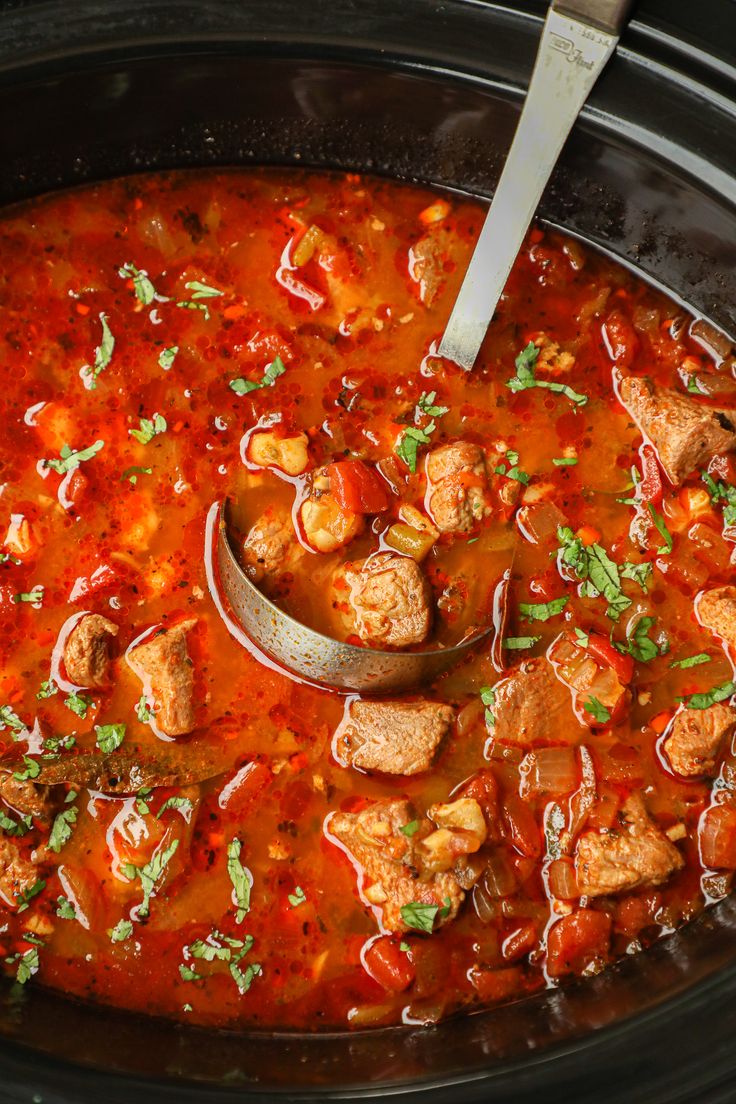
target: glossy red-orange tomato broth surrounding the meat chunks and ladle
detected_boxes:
[0,171,736,1030]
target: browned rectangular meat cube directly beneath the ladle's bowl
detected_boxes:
[333,701,455,774]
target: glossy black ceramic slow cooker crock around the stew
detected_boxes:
[0,0,736,1104]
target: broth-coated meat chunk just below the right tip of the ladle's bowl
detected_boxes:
[491,657,585,746]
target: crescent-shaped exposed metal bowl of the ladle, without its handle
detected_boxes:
[209,502,503,693]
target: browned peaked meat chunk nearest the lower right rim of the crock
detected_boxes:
[575,793,684,896]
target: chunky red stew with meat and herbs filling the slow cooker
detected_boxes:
[0,171,736,1030]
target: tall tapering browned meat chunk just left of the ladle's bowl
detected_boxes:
[128,618,196,736]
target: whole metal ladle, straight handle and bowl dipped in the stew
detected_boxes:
[209,0,631,693]
